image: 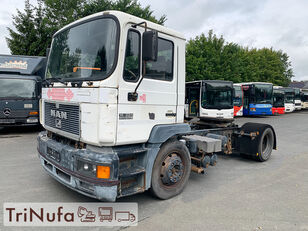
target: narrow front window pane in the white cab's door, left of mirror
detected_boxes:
[123,30,140,82]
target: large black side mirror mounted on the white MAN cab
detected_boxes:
[142,30,158,61]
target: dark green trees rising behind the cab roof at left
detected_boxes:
[6,0,166,55]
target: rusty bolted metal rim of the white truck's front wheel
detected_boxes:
[160,153,184,186]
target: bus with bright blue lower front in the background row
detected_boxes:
[240,82,273,116]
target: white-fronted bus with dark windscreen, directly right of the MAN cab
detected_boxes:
[185,80,234,122]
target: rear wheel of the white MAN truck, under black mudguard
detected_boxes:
[256,128,275,162]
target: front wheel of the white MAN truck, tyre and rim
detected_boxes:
[150,140,191,200]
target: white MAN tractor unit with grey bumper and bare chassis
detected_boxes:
[38,11,276,201]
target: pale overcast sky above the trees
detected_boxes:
[0,0,308,80]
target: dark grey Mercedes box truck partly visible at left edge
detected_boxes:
[0,55,46,127]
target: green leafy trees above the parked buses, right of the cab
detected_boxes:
[186,31,293,86]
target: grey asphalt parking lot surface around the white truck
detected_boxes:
[0,111,308,231]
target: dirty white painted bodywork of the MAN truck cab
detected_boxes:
[41,11,185,146]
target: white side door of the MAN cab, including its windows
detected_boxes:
[117,25,177,144]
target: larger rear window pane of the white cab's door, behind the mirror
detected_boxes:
[144,38,173,81]
